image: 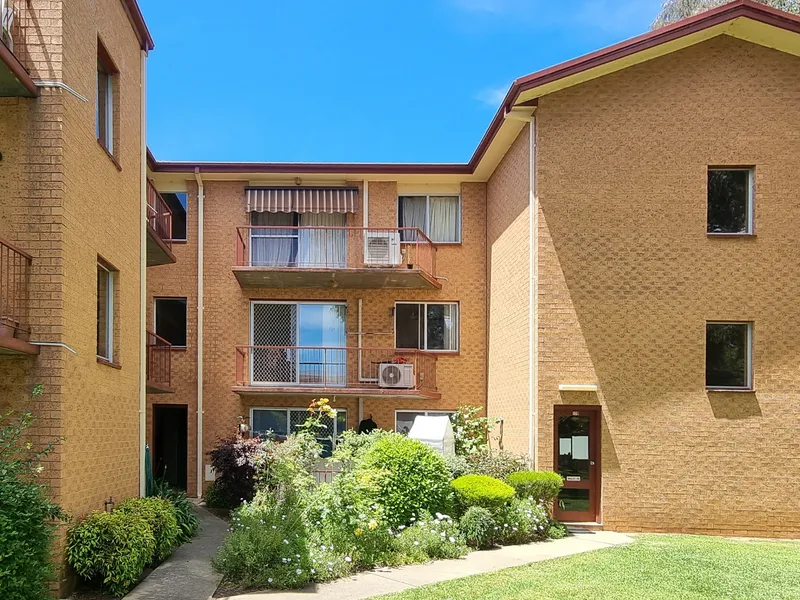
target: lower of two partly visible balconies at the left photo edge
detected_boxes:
[0,239,39,355]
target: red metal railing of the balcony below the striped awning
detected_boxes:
[236,226,436,277]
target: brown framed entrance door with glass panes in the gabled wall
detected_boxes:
[553,406,600,523]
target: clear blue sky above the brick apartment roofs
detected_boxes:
[139,0,660,162]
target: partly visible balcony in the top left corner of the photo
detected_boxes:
[0,0,39,98]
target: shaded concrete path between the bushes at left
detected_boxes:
[125,506,228,600]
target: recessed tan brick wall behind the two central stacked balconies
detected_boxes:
[148,181,486,491]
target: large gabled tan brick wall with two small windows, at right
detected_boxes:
[537,36,800,537]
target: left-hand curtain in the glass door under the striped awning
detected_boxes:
[250,212,297,267]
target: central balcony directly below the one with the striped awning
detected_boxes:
[233,346,441,399]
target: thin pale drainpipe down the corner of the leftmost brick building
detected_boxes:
[139,50,147,497]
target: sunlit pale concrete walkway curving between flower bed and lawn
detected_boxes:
[219,531,633,600]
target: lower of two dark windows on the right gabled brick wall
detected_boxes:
[706,323,753,390]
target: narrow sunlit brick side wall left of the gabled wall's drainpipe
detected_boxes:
[486,126,531,454]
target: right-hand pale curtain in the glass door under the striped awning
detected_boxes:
[297,213,347,269]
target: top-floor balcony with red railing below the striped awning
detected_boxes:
[233,226,442,289]
